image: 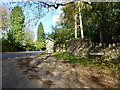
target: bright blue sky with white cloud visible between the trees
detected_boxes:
[0,0,62,41]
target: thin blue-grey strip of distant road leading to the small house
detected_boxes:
[2,51,45,59]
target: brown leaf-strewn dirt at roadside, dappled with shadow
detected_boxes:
[16,55,120,88]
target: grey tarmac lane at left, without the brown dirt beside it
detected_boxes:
[0,52,45,88]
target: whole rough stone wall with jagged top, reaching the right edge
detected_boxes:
[66,39,120,61]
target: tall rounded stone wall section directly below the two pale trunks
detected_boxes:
[66,39,91,57]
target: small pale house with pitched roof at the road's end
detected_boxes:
[44,37,54,53]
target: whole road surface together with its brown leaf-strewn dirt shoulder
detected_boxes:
[0,52,119,88]
